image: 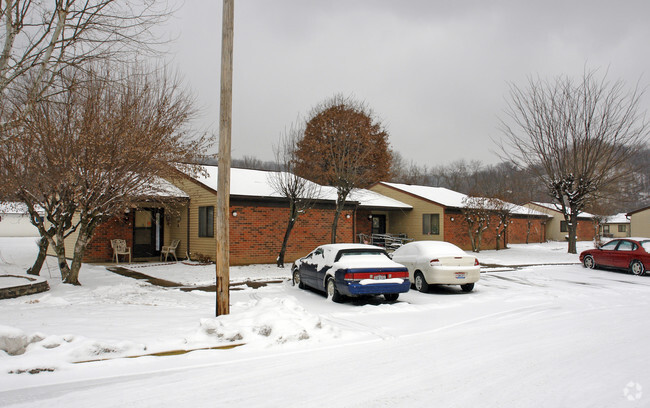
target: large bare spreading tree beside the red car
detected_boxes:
[500,72,648,253]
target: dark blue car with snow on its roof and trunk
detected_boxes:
[291,244,411,302]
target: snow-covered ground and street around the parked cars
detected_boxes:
[0,238,650,407]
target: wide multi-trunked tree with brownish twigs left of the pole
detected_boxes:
[0,65,205,284]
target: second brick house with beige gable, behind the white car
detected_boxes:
[370,182,548,250]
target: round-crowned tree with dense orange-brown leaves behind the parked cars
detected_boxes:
[295,95,391,242]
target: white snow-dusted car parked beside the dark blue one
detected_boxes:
[392,241,481,292]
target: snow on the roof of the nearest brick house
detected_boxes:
[189,166,412,208]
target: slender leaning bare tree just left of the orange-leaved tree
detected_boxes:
[269,121,320,268]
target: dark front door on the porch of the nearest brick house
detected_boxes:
[133,208,164,258]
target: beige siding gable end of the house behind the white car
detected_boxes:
[370,184,445,241]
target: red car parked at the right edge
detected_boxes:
[580,238,650,275]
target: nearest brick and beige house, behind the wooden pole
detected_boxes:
[57,166,410,265]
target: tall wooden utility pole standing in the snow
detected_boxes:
[217,0,234,316]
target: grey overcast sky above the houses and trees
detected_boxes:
[168,0,650,166]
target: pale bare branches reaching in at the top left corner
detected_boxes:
[0,0,170,102]
